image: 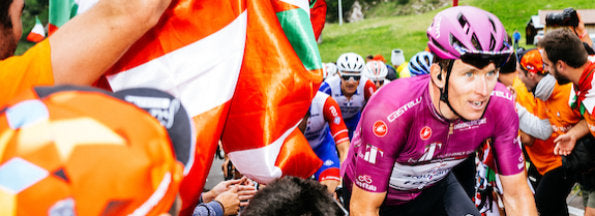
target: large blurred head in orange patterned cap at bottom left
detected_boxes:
[0,86,194,215]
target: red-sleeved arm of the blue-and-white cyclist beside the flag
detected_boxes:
[323,96,349,163]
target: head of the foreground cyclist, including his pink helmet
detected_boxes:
[427,6,512,120]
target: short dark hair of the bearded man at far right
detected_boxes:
[537,28,587,68]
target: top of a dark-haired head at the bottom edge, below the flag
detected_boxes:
[242,176,340,216]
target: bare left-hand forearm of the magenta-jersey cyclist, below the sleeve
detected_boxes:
[349,184,386,216]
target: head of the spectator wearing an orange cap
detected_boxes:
[519,49,547,90]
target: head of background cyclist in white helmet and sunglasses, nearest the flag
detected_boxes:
[337,52,366,95]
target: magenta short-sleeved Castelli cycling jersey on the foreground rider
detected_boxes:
[341,76,524,205]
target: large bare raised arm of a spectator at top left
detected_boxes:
[49,0,171,85]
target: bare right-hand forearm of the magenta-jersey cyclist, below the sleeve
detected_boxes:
[500,172,537,215]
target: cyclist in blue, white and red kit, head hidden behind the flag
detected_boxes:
[299,92,349,193]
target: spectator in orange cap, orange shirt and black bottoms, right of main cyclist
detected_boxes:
[519,49,593,215]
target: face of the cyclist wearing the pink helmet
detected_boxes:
[448,60,498,120]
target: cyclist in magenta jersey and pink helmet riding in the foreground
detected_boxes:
[342,6,537,215]
